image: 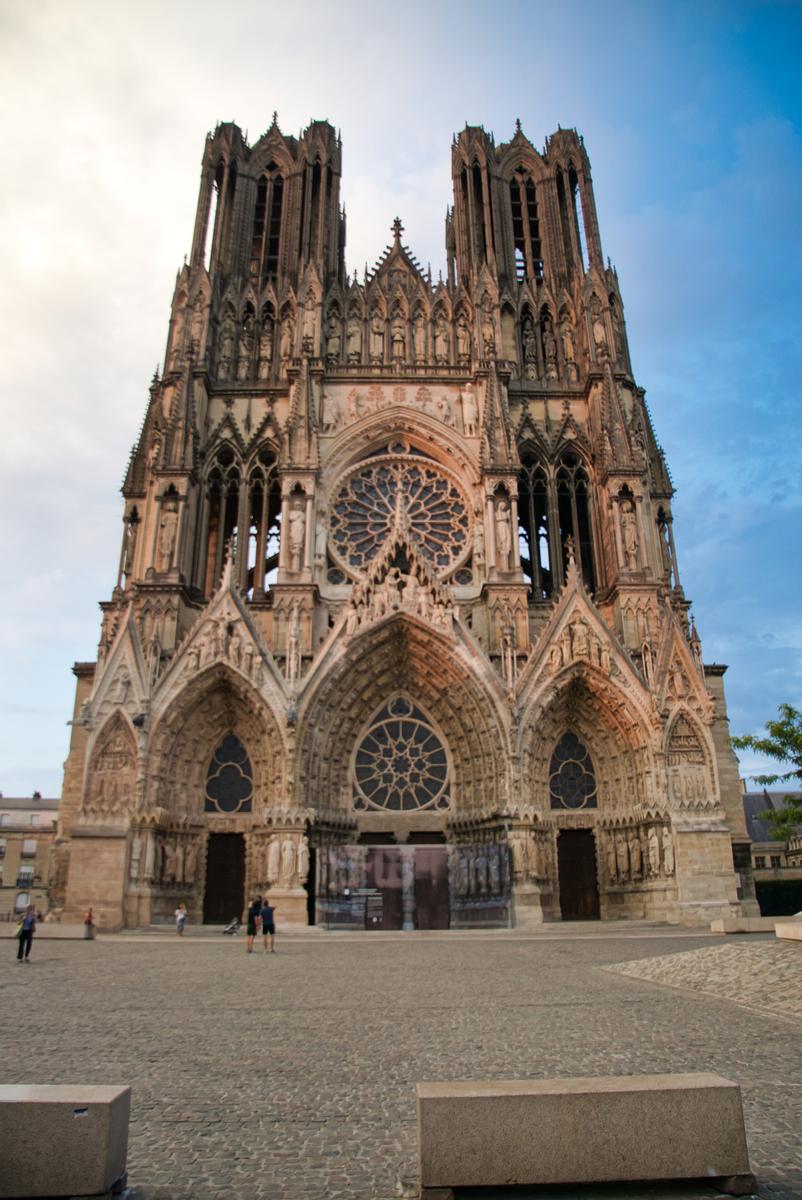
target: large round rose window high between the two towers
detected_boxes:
[329,455,471,574]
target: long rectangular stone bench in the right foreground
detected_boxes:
[418,1074,754,1200]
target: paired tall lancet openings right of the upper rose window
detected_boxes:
[517,451,595,600]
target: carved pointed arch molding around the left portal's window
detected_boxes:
[146,662,287,824]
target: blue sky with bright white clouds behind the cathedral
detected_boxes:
[0,0,802,796]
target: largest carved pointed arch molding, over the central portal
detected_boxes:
[297,613,510,820]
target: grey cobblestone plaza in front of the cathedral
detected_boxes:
[0,925,802,1200]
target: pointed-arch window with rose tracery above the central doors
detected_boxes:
[353,696,449,812]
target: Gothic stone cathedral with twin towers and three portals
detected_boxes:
[53,115,756,930]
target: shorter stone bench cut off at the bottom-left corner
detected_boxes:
[0,1084,131,1200]
